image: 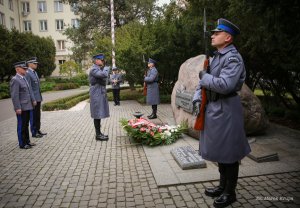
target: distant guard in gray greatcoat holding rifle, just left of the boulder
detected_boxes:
[144,58,160,119]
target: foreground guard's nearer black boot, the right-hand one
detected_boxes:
[214,162,239,208]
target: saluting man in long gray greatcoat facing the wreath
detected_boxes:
[89,53,109,141]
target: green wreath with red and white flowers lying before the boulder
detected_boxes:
[120,118,188,146]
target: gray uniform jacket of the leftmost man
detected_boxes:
[10,74,35,111]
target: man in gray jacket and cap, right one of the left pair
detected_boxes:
[25,57,47,138]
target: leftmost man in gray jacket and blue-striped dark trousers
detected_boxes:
[10,61,36,149]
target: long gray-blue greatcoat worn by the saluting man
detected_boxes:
[89,64,109,119]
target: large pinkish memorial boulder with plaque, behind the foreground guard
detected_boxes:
[171,55,269,138]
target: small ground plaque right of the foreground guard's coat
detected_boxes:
[248,143,279,163]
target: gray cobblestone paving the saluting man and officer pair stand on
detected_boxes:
[0,101,300,208]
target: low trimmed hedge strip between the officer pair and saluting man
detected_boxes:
[42,92,90,111]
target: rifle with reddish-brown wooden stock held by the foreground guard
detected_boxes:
[194,8,210,131]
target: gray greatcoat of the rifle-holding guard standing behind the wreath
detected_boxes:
[144,67,160,105]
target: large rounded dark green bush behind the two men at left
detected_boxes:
[0,25,56,81]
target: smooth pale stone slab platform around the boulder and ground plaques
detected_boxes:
[144,109,300,186]
